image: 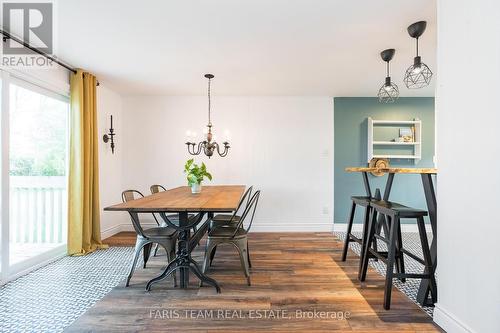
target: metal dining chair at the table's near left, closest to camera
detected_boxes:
[122,190,178,287]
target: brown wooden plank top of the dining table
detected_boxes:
[104,185,245,213]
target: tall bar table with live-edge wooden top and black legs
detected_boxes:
[345,167,438,305]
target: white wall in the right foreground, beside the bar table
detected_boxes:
[434,0,500,333]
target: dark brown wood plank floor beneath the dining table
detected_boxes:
[67,233,440,332]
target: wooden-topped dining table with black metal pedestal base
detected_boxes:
[104,185,245,293]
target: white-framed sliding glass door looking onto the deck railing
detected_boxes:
[1,73,69,280]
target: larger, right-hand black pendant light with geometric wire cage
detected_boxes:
[403,21,432,89]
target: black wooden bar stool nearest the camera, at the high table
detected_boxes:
[360,200,436,310]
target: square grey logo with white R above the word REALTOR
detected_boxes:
[2,2,53,55]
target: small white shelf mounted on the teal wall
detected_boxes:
[367,117,422,164]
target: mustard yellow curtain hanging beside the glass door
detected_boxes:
[68,70,106,255]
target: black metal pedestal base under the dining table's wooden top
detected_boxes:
[146,212,221,293]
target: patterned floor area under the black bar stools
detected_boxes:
[334,232,434,317]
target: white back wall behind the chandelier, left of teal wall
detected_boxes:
[119,96,333,231]
